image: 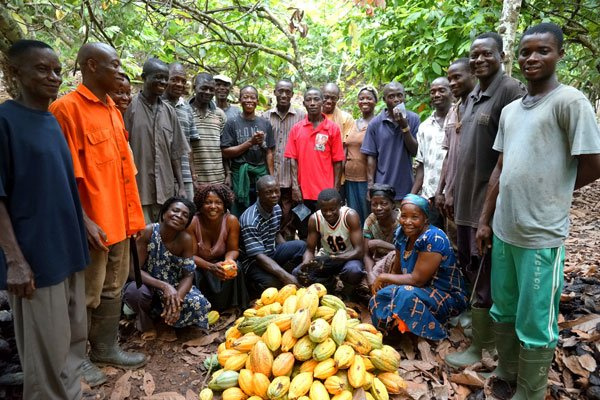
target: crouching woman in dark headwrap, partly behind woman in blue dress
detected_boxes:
[363,183,400,288]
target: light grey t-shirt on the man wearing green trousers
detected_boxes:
[492,85,600,249]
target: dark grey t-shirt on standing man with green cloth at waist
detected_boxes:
[221,115,275,165]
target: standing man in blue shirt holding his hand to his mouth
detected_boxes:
[360,82,420,201]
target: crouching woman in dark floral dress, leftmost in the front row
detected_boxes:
[123,197,210,340]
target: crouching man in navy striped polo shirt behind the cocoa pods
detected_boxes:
[240,175,306,294]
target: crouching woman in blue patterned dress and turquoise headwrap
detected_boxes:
[369,194,467,340]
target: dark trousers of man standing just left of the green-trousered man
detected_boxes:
[456,225,492,308]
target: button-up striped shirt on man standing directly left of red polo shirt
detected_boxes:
[262,107,306,188]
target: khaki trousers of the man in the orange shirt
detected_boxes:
[85,238,129,309]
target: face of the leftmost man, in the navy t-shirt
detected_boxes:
[11,48,62,103]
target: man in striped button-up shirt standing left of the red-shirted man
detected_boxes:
[263,79,306,239]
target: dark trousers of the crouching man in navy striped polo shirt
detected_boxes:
[244,240,306,298]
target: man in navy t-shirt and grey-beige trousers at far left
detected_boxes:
[0,40,89,400]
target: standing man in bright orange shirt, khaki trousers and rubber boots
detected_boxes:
[50,43,146,386]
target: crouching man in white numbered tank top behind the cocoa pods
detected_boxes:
[294,189,365,294]
